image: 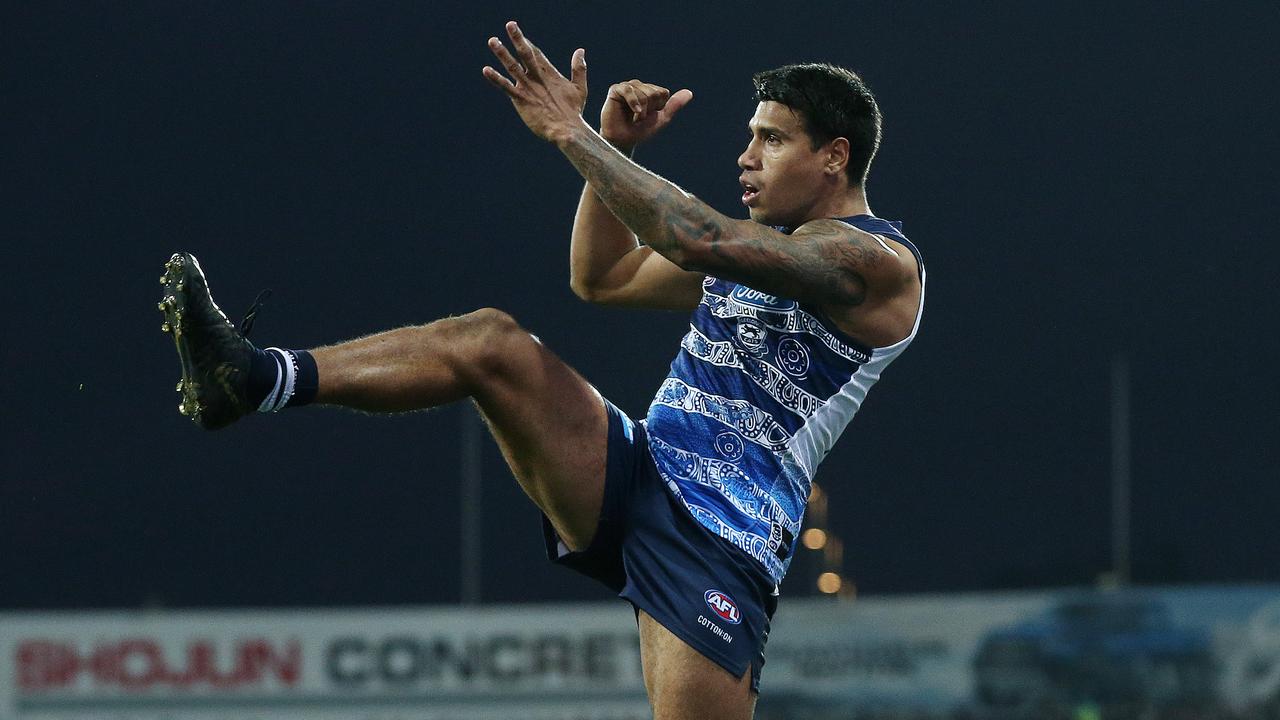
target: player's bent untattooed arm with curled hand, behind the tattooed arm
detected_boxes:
[570,79,703,310]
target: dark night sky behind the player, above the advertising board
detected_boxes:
[0,1,1280,609]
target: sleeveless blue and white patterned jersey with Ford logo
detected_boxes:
[645,215,924,582]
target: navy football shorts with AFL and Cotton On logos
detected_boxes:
[543,400,778,692]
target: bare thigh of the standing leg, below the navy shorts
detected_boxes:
[639,610,755,720]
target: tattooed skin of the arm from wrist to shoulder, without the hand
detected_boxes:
[561,124,886,305]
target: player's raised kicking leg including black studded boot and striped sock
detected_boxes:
[160,254,608,550]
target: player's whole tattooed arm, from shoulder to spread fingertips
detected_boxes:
[484,22,914,306]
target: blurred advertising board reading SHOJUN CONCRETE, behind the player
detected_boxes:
[0,585,1280,720]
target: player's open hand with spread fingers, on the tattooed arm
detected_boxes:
[483,20,586,142]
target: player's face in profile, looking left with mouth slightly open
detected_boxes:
[737,101,829,227]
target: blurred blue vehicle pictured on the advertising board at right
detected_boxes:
[973,594,1213,716]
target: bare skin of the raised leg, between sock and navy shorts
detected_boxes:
[311,309,608,550]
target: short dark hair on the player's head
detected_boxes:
[751,63,881,186]
